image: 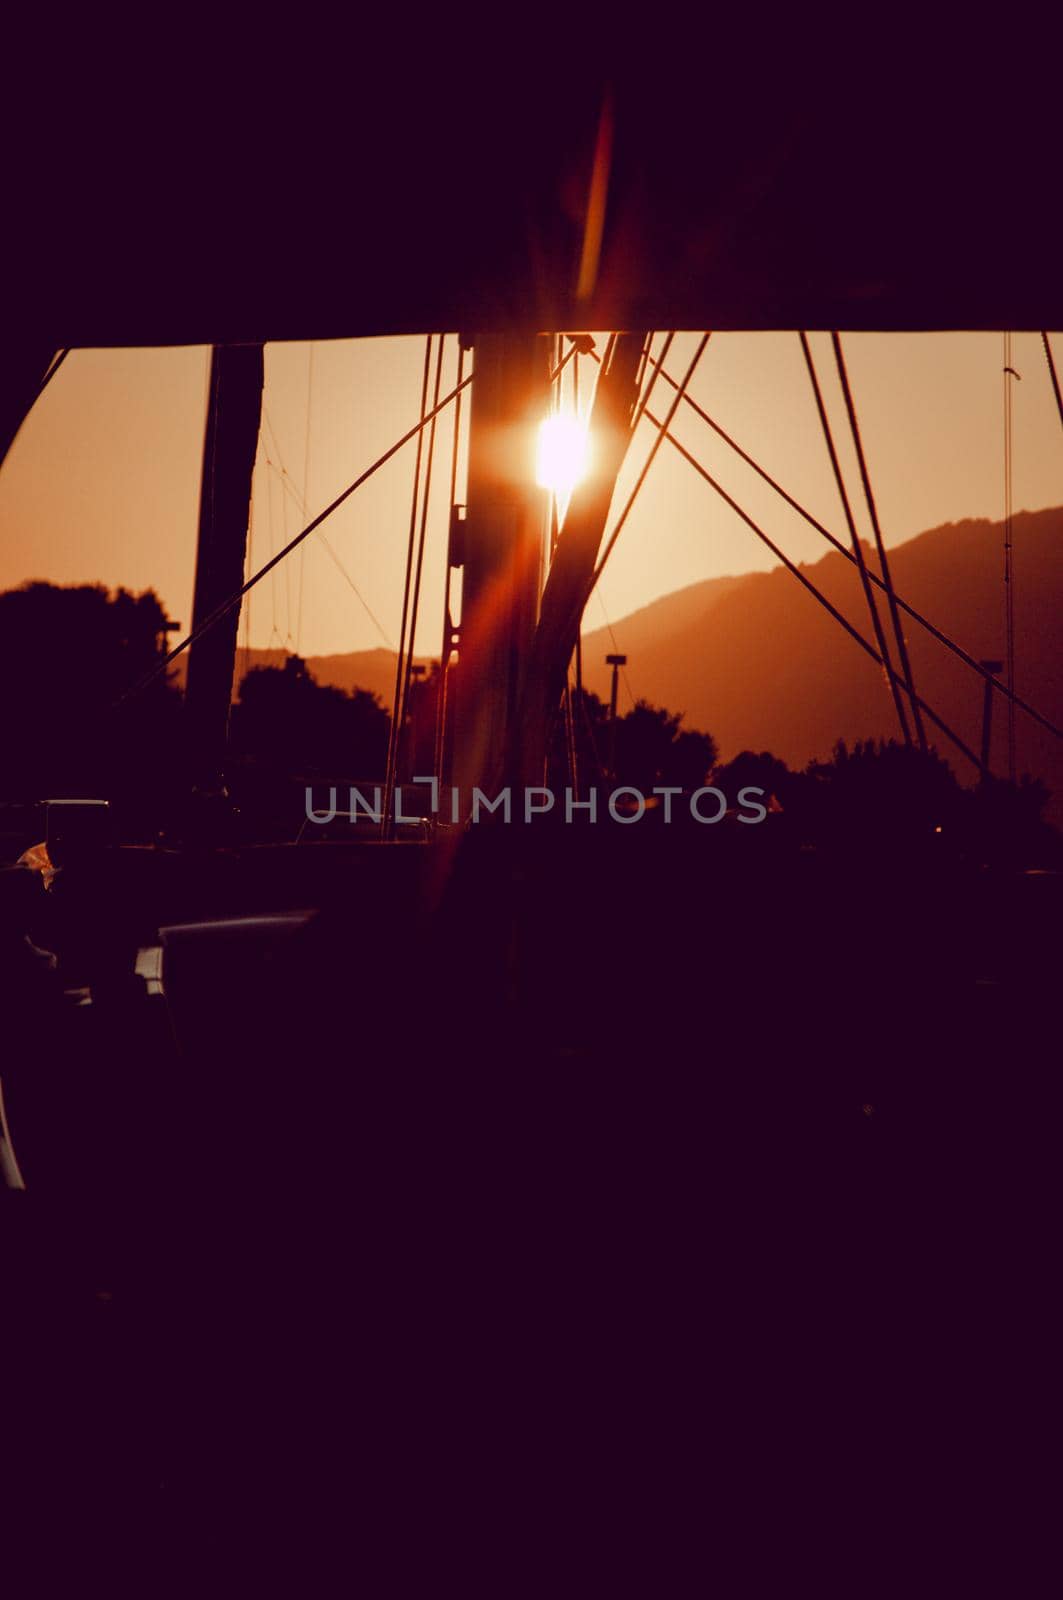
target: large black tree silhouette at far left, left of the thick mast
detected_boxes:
[0,582,183,816]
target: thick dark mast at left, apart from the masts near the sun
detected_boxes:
[186,344,264,794]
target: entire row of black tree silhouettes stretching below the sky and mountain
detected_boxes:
[0,582,1063,869]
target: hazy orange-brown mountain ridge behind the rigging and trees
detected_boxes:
[178,507,1063,821]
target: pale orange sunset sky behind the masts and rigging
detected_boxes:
[0,333,1063,691]
